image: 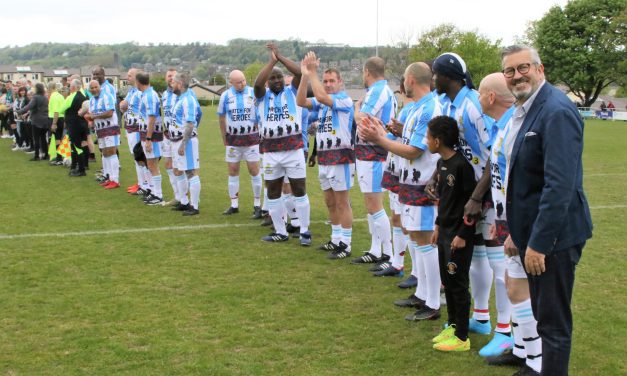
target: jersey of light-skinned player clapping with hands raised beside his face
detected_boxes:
[311,91,355,166]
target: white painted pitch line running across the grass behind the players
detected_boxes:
[0,205,627,240]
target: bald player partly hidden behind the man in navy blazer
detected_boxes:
[465,72,542,372]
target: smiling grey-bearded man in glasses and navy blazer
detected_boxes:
[501,46,592,375]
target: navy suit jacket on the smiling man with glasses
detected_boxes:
[506,82,592,254]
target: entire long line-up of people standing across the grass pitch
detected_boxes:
[6,44,592,375]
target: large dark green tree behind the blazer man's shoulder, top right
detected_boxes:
[528,0,627,107]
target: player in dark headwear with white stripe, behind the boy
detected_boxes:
[433,52,514,356]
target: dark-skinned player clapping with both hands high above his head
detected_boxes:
[254,43,311,246]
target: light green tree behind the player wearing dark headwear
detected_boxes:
[409,24,501,85]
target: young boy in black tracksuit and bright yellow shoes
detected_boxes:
[427,116,476,351]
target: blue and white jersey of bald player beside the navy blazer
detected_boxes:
[490,106,520,220]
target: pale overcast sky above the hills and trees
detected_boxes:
[0,0,567,47]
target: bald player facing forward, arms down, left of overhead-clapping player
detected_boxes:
[218,70,261,219]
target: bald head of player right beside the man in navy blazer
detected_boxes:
[479,72,516,120]
